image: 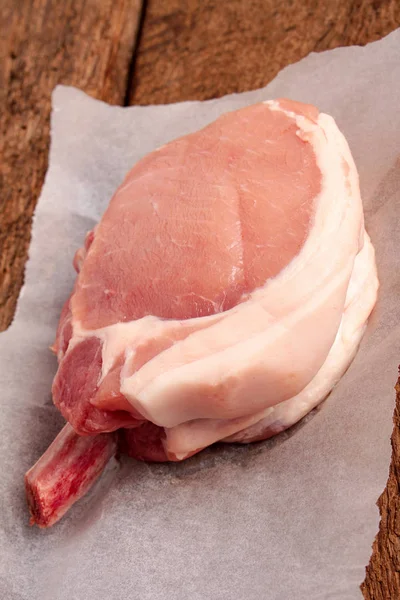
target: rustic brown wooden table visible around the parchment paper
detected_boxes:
[0,0,400,600]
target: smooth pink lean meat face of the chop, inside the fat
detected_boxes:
[71,104,321,329]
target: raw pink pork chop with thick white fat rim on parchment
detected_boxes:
[27,100,378,525]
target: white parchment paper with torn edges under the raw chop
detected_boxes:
[0,30,400,600]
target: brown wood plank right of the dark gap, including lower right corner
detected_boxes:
[129,0,400,600]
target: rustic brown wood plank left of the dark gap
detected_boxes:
[0,0,142,330]
